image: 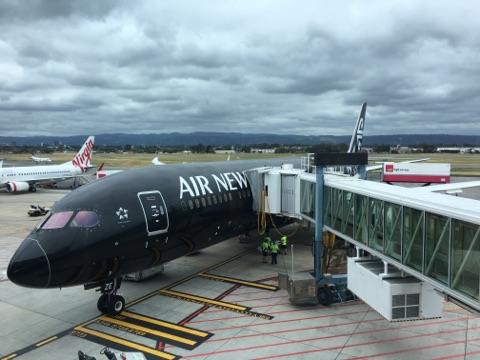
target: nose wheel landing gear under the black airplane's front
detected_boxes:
[84,277,125,315]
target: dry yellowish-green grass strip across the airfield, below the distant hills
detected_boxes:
[0,153,480,176]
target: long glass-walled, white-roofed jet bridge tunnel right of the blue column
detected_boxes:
[323,176,480,311]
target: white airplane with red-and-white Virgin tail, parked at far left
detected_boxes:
[0,136,95,192]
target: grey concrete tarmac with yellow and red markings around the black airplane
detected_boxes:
[0,184,480,360]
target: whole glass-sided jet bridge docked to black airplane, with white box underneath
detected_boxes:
[247,154,480,320]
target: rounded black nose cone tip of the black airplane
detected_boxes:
[7,238,51,288]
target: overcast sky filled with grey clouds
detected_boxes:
[0,0,480,136]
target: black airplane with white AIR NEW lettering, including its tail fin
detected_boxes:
[7,104,365,315]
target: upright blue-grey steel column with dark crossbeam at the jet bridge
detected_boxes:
[314,153,368,283]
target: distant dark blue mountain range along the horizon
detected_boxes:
[0,132,480,147]
